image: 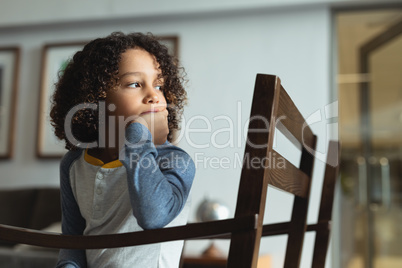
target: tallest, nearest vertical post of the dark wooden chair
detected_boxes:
[227,75,280,268]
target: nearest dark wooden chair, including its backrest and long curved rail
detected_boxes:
[0,74,316,268]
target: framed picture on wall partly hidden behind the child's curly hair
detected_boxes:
[36,35,179,159]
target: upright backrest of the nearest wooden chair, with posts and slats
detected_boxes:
[228,74,317,267]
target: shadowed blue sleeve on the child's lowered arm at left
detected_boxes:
[56,150,87,268]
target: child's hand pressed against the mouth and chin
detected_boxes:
[133,109,169,145]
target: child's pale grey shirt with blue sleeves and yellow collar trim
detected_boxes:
[57,123,195,268]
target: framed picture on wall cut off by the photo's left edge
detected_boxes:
[0,47,20,159]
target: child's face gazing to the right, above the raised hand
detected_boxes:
[106,49,166,122]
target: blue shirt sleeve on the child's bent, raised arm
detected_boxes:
[120,123,195,229]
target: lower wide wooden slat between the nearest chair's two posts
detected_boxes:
[267,150,310,197]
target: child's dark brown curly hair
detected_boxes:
[50,32,187,150]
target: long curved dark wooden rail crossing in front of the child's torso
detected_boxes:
[0,216,256,249]
